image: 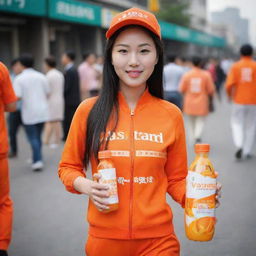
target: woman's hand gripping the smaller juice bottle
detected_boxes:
[74,174,109,211]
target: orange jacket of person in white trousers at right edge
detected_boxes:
[225,57,256,105]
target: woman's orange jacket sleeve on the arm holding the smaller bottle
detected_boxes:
[58,101,92,194]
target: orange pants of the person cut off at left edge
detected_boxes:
[0,158,13,250]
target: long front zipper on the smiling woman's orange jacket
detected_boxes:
[129,110,134,238]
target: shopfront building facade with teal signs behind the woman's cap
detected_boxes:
[0,0,225,71]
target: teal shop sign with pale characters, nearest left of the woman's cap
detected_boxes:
[49,0,101,26]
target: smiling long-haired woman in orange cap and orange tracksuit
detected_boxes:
[59,8,220,256]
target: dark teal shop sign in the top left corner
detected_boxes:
[0,0,47,16]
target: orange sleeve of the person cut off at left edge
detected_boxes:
[0,62,18,105]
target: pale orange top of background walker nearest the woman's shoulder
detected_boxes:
[179,67,215,116]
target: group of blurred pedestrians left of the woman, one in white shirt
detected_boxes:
[5,51,103,170]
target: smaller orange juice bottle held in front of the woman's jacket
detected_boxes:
[97,150,118,213]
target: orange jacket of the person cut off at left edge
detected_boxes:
[0,62,17,159]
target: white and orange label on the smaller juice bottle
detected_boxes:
[98,168,118,204]
